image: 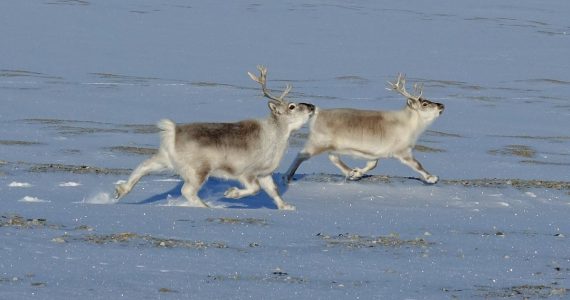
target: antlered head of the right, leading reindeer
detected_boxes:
[387,74,445,122]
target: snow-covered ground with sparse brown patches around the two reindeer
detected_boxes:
[0,0,570,299]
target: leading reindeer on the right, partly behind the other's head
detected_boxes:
[284,74,444,184]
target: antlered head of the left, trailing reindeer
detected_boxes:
[247,66,315,130]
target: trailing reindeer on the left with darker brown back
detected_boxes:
[115,66,315,210]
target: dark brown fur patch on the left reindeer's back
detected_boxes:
[176,120,261,150]
